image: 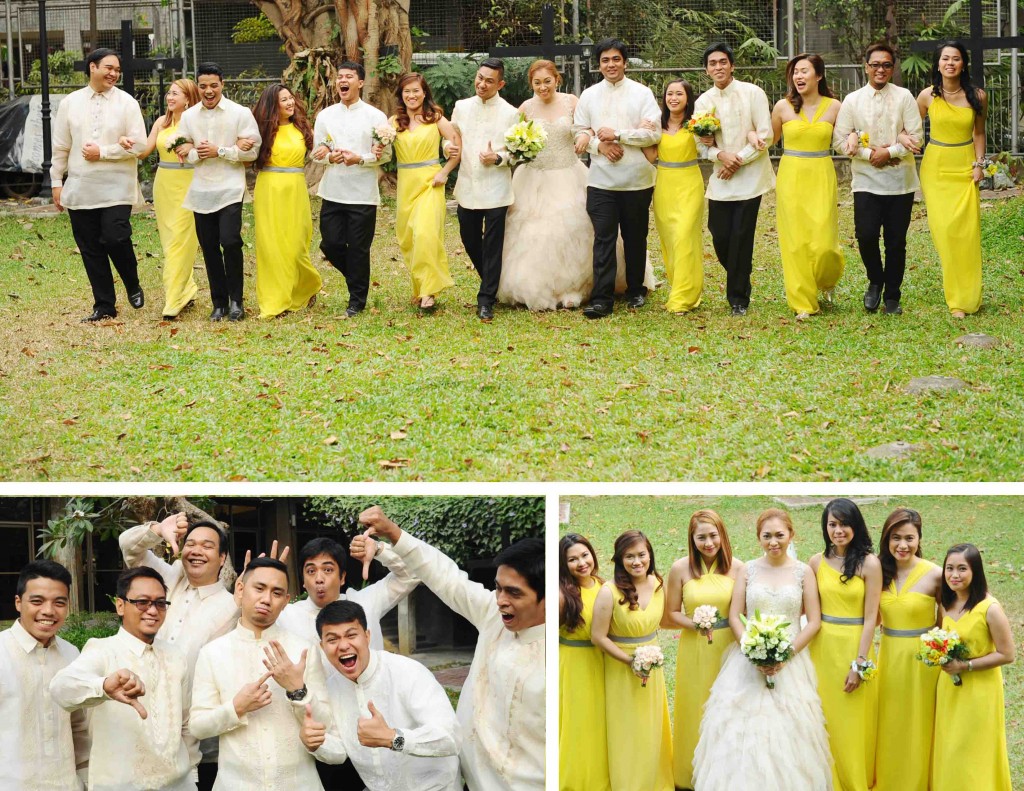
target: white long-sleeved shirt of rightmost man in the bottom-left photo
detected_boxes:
[394,533,545,791]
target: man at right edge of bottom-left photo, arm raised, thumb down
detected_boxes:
[359,505,545,791]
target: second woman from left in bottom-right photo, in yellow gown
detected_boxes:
[591,530,675,791]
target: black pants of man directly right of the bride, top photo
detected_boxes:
[587,186,654,306]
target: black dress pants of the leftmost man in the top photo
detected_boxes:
[68,205,139,316]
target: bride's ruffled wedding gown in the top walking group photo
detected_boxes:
[498,94,656,310]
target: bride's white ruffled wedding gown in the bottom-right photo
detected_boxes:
[693,559,833,791]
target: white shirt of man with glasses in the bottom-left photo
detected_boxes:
[50,628,200,791]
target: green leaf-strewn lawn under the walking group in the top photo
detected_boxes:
[0,192,1024,482]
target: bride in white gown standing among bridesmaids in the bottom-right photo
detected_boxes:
[693,508,833,791]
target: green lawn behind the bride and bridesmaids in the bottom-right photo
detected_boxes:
[559,496,1024,791]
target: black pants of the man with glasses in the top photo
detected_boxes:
[853,192,913,302]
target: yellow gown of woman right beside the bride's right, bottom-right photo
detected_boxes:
[810,557,885,791]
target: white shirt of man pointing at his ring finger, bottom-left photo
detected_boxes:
[190,621,332,791]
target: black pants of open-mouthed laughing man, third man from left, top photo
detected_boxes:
[321,201,377,310]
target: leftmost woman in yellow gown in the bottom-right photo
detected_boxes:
[558,533,611,791]
